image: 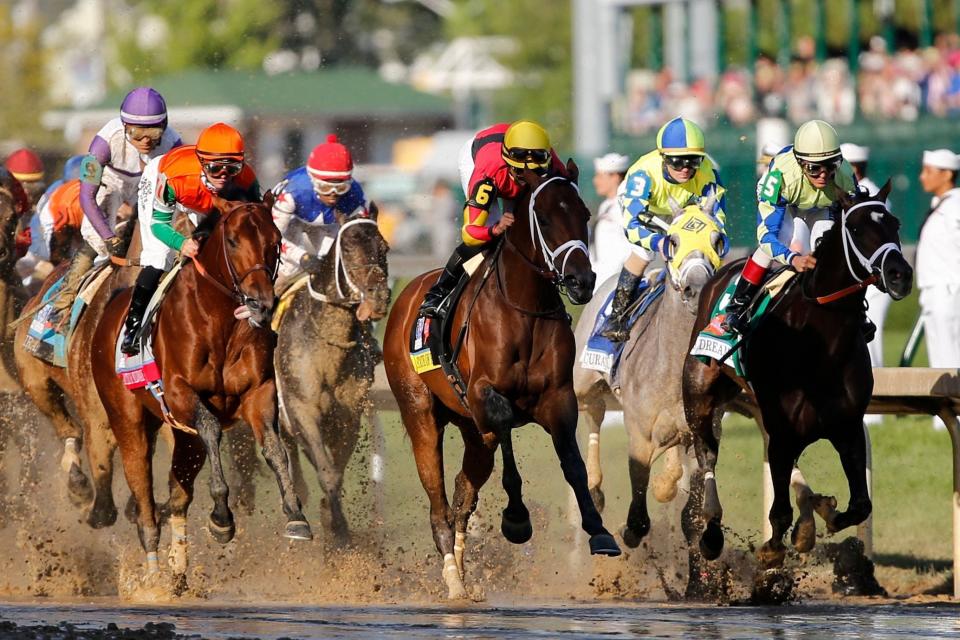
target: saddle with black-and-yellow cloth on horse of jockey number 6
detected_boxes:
[410,250,492,406]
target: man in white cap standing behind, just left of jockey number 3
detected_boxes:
[590,153,630,289]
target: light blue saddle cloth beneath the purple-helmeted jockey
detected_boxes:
[23,262,113,367]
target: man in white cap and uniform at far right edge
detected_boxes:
[917,149,960,420]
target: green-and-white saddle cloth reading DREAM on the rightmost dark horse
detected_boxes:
[690,269,797,379]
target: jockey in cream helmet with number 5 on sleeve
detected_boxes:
[724,120,854,333]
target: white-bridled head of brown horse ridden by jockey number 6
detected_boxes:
[511,160,597,304]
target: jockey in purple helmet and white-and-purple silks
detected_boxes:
[54,87,183,320]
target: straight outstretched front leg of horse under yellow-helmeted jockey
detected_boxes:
[534,388,620,556]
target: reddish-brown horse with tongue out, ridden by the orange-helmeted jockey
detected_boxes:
[93,200,312,582]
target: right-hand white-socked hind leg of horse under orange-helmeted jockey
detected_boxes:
[161,429,206,591]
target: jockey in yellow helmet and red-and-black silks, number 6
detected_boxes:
[420,120,566,317]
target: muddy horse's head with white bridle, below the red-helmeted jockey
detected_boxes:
[336,202,390,322]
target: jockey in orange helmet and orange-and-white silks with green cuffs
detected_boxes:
[120,122,261,355]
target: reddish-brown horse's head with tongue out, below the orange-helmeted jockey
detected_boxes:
[210,196,280,326]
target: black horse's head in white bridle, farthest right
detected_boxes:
[835,180,913,300]
